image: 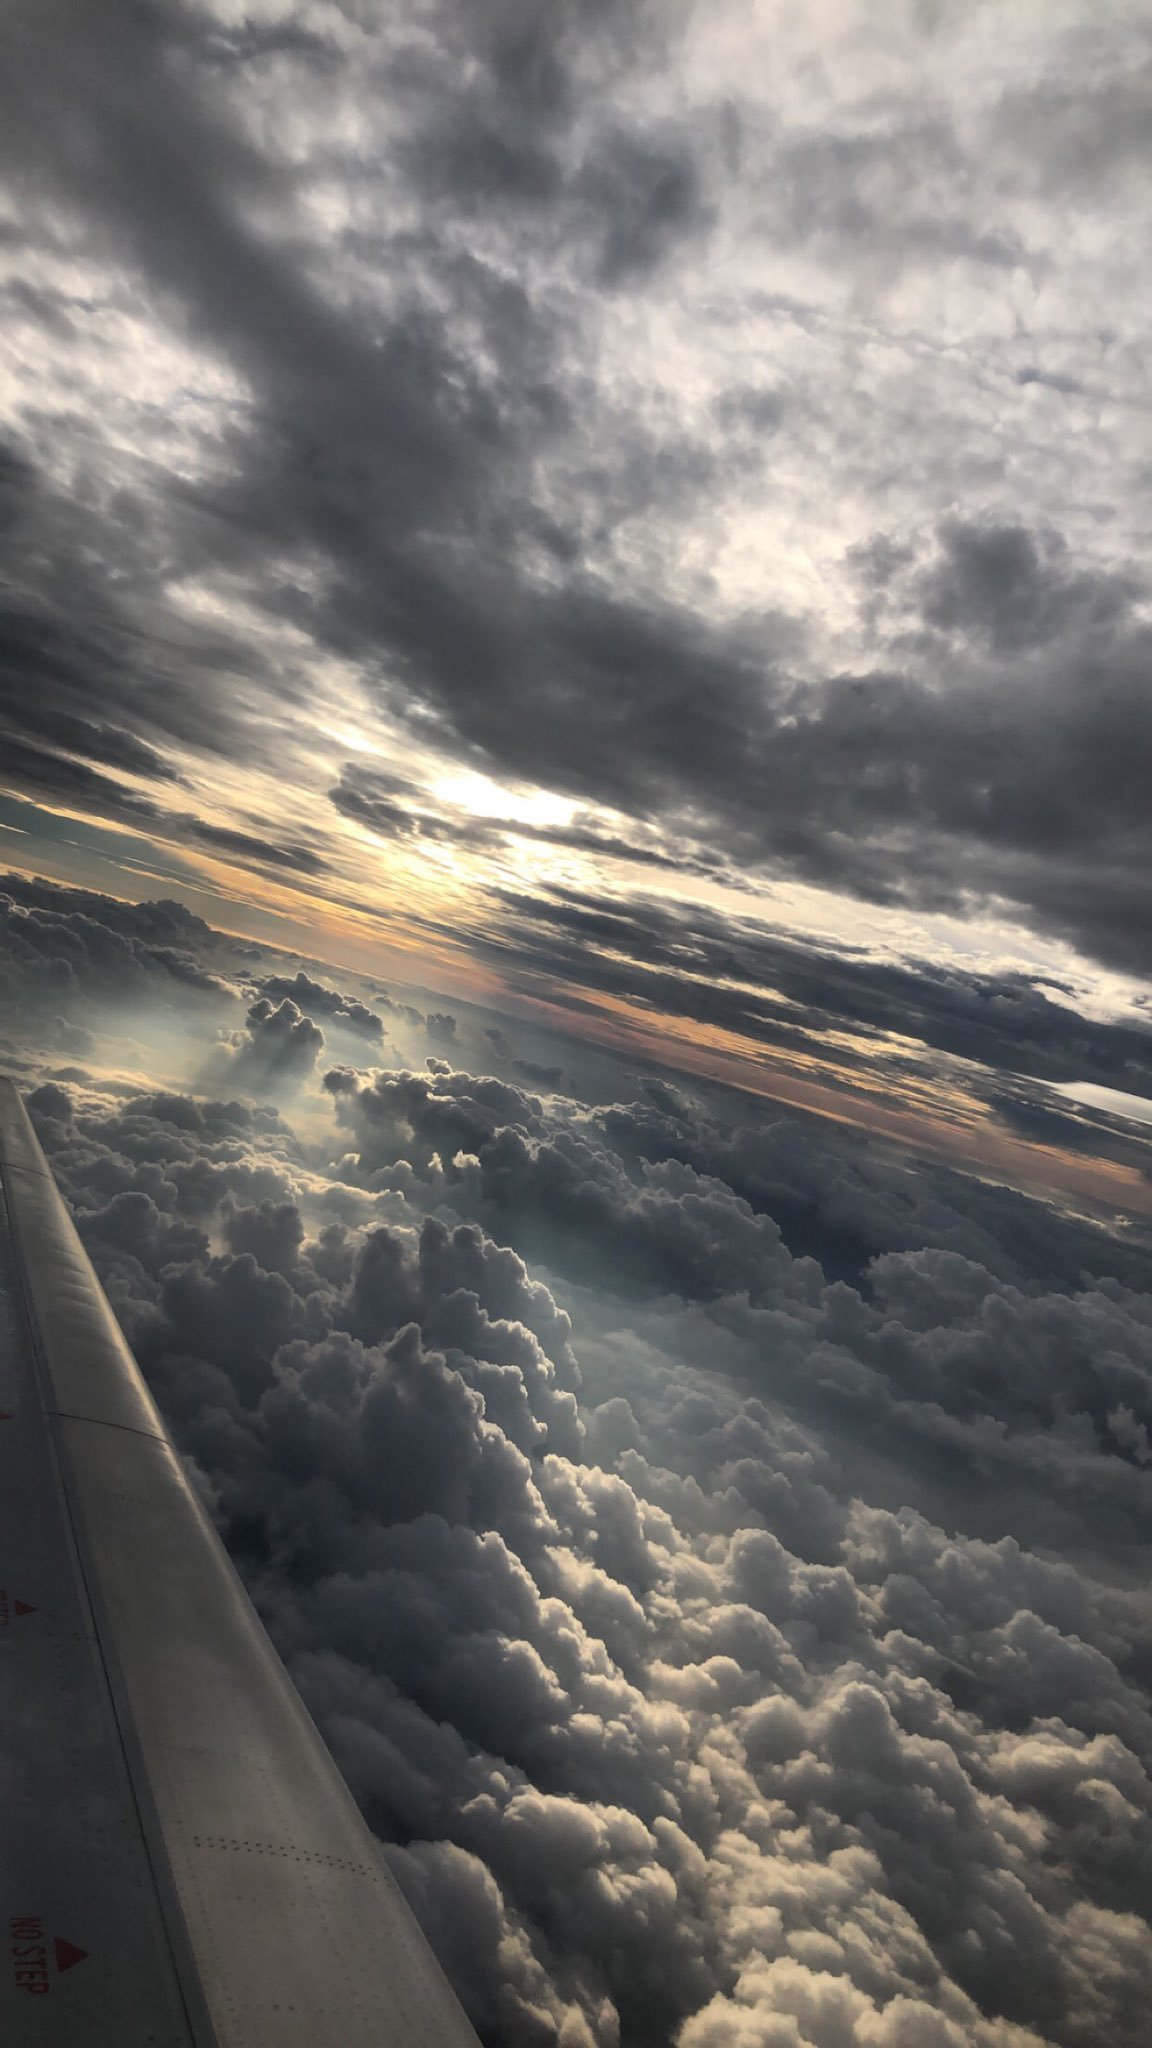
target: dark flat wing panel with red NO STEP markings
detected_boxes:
[0,1171,193,2048]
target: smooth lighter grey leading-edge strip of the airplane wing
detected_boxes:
[0,1083,476,2048]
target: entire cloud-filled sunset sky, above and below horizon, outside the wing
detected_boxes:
[0,0,1152,2048]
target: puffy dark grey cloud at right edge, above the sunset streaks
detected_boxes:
[717,548,1152,971]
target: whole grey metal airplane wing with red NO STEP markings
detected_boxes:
[0,1081,478,2048]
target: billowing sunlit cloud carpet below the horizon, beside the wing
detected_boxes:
[20,1063,1152,2048]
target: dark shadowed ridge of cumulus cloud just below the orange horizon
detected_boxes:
[326,1063,1144,1292]
